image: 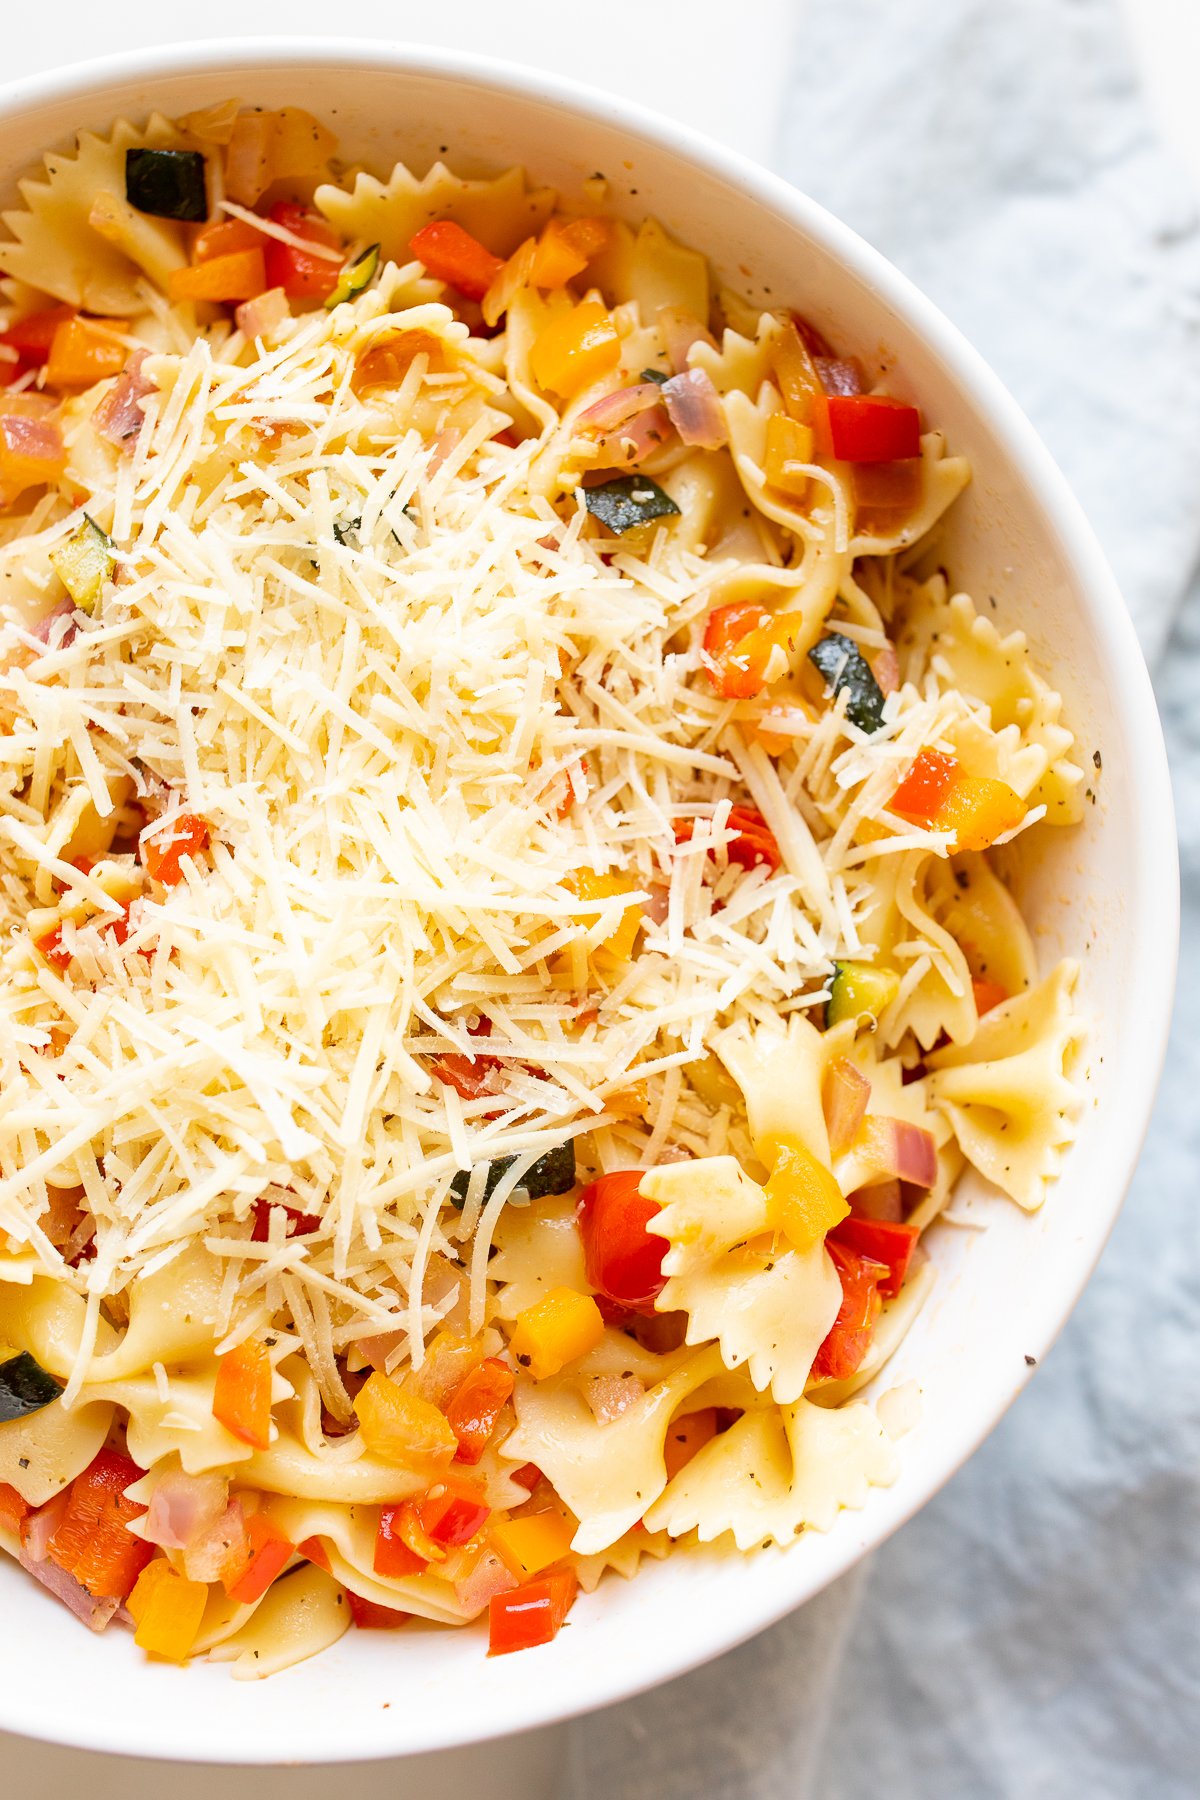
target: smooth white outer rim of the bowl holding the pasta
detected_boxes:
[0,34,1180,1764]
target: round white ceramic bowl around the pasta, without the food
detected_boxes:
[0,40,1178,1762]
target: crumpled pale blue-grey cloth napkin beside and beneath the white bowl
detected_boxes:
[570,0,1200,1800]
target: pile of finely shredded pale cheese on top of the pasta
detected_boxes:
[0,270,993,1415]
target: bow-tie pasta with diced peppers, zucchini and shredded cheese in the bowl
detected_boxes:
[0,101,1083,1676]
